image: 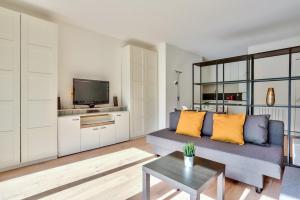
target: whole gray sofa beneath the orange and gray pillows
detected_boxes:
[147,111,284,192]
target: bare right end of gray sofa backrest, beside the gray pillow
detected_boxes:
[269,120,284,146]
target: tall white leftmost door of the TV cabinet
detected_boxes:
[58,116,80,156]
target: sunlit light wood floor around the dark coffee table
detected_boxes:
[0,138,280,200]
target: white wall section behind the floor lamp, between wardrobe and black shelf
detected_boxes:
[158,43,202,128]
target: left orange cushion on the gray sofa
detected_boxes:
[176,111,205,137]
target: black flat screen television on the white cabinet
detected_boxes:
[73,78,109,108]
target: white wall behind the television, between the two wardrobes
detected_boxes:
[58,24,122,108]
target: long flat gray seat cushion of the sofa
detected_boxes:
[150,129,283,165]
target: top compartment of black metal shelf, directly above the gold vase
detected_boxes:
[254,55,289,79]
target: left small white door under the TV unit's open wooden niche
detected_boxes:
[81,127,100,151]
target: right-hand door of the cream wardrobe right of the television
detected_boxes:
[143,50,158,134]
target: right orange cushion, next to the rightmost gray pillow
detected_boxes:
[211,113,246,145]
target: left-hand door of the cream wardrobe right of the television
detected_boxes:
[130,47,144,138]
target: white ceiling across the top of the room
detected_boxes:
[7,0,300,58]
